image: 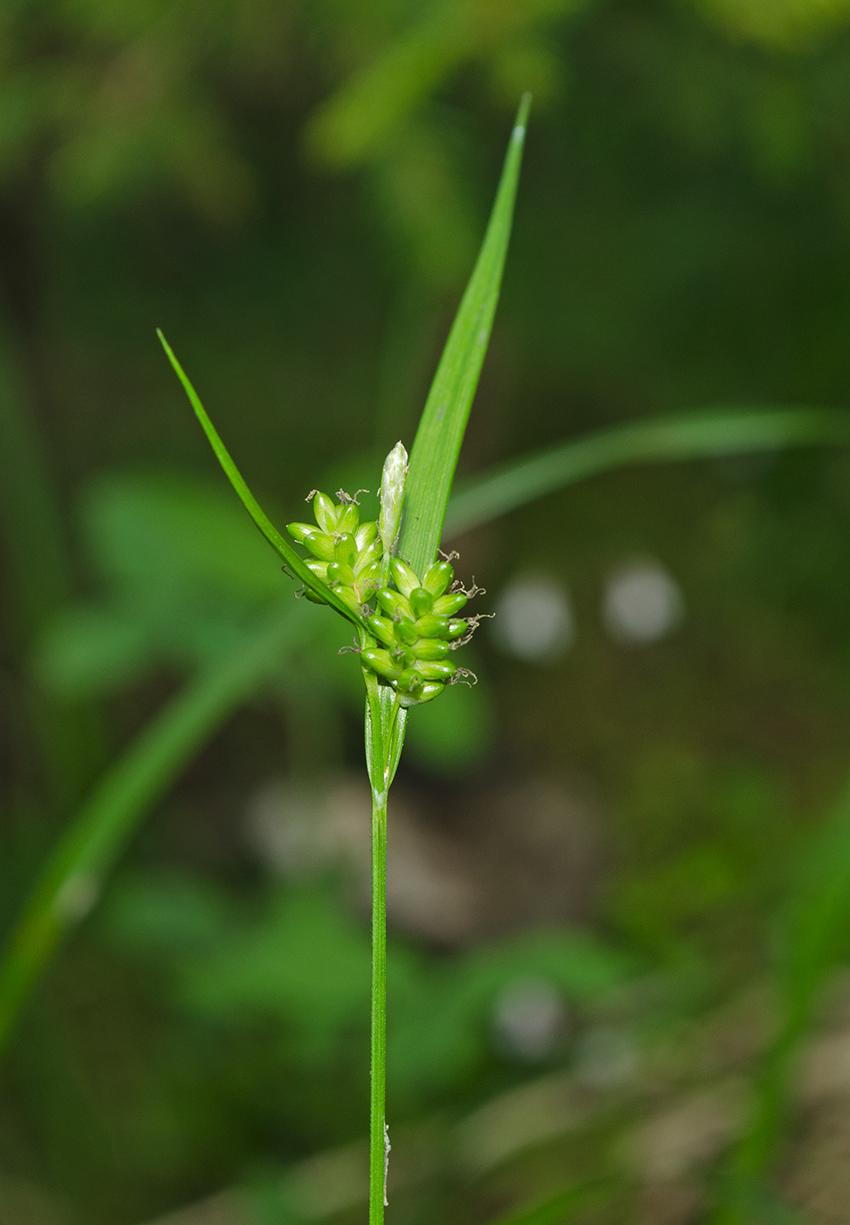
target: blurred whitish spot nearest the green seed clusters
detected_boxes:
[492,575,573,664]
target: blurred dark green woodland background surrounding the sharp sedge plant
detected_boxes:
[8,0,850,1225]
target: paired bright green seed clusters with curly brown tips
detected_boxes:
[287,492,476,706]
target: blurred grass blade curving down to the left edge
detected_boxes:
[0,601,312,1049]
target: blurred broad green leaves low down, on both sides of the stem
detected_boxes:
[105,880,630,1122]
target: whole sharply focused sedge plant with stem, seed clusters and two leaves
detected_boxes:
[159,96,530,1225]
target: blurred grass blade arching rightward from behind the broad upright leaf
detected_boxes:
[446,408,850,534]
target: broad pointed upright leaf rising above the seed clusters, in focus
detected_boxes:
[399,94,532,573]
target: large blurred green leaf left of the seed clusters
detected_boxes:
[39,478,290,696]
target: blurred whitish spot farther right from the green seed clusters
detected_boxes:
[603,561,685,644]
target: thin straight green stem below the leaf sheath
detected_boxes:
[369,788,389,1225]
